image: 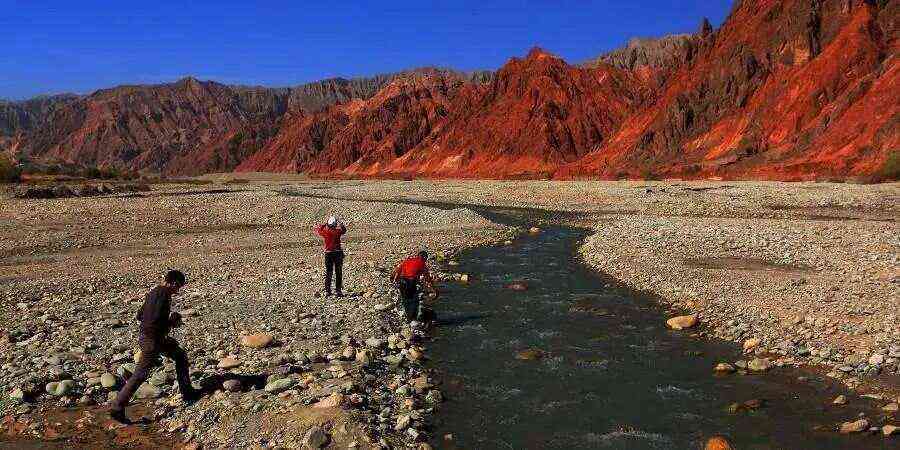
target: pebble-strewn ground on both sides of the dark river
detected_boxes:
[0,181,900,447]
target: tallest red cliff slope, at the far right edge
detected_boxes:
[557,0,900,179]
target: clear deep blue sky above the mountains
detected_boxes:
[0,0,731,99]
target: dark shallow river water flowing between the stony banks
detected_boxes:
[429,207,896,449]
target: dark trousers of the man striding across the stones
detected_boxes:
[112,336,193,410]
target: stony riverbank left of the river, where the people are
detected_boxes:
[0,184,511,448]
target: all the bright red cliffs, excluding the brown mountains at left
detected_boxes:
[244,0,900,180]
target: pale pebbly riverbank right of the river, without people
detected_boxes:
[284,181,900,400]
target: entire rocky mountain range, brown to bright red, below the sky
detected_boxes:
[0,0,900,180]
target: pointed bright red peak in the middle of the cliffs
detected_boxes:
[372,49,647,178]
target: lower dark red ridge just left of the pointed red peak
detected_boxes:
[238,70,468,174]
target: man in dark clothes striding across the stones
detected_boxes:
[110,270,199,423]
